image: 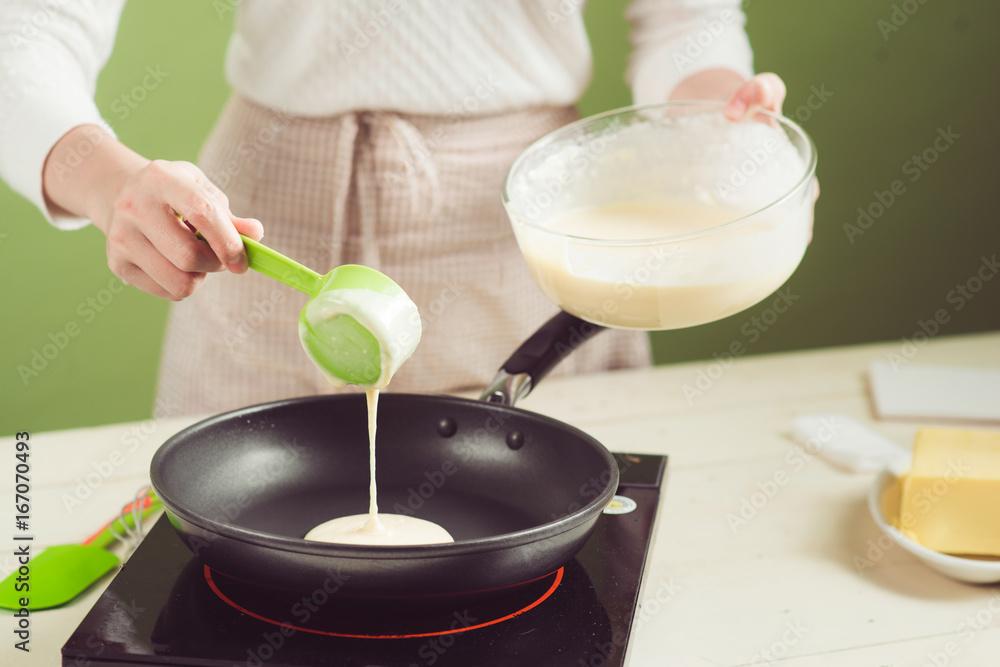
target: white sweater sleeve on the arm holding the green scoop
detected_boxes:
[0,0,125,229]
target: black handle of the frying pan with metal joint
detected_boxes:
[480,310,604,405]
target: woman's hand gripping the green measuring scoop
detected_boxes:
[43,128,263,301]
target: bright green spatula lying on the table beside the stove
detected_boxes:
[0,496,162,611]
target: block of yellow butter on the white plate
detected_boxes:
[899,428,1000,556]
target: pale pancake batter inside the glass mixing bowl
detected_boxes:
[522,198,807,330]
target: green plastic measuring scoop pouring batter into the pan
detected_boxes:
[241,235,416,389]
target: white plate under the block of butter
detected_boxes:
[868,471,1000,584]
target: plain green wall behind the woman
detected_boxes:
[0,0,1000,434]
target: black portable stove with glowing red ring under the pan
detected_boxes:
[62,454,666,667]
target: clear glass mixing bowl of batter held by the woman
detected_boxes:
[503,101,816,330]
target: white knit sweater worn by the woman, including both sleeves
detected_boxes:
[0,0,752,229]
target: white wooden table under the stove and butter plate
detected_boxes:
[0,333,1000,667]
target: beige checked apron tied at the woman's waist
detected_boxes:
[158,96,650,414]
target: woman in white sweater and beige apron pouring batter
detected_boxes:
[0,0,785,414]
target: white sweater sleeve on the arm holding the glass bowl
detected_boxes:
[626,0,753,104]
